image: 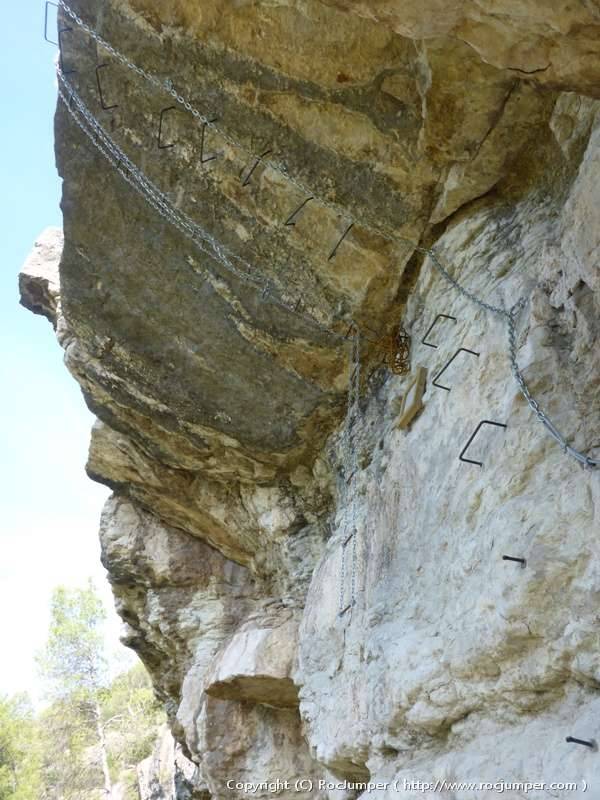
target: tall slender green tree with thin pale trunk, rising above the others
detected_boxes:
[39,583,112,800]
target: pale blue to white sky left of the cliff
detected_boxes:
[0,0,131,696]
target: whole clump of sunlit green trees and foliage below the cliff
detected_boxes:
[0,584,165,800]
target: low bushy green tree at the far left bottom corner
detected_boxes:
[0,695,41,800]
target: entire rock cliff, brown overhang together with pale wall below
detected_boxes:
[21,0,600,800]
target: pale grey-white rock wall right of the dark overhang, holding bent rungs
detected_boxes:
[296,122,600,784]
